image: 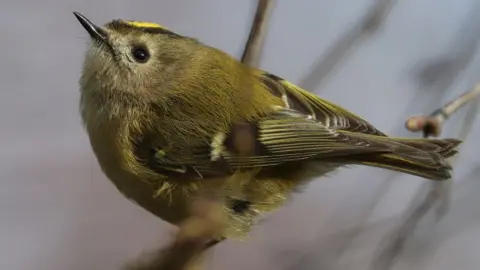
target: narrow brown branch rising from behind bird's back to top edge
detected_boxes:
[241,0,275,67]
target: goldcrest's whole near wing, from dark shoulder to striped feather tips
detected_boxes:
[146,107,393,179]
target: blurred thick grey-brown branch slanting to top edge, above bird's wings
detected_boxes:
[299,0,396,91]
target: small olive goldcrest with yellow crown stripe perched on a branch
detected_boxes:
[75,12,460,243]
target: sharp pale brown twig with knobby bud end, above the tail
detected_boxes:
[405,84,480,138]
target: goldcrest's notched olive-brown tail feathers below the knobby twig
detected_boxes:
[349,137,461,180]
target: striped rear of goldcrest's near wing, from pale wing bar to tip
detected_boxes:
[218,108,393,169]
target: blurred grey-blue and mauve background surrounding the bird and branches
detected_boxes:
[0,0,480,270]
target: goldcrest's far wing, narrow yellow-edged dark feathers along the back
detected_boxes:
[258,70,386,136]
